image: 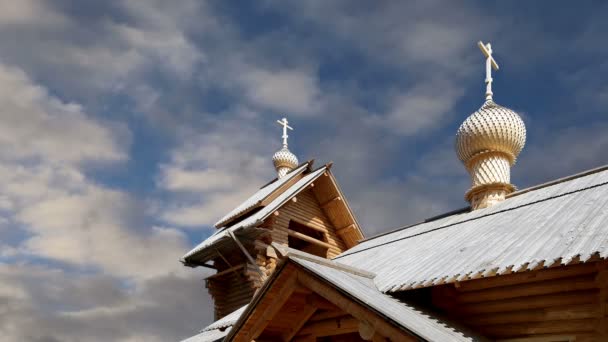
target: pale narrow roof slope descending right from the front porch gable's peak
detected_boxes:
[290,255,485,341]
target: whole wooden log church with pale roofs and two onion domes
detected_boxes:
[182,43,608,342]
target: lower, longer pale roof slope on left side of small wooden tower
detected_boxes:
[183,166,327,261]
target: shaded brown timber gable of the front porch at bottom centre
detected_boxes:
[227,262,416,342]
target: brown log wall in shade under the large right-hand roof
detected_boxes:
[432,262,608,342]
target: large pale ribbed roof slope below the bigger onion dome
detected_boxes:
[334,170,608,292]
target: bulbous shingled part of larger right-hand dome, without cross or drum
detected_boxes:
[456,100,526,165]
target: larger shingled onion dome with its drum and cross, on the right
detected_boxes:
[456,42,526,210]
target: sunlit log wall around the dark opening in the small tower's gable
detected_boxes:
[268,189,346,258]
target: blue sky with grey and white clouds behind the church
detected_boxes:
[0,0,608,342]
